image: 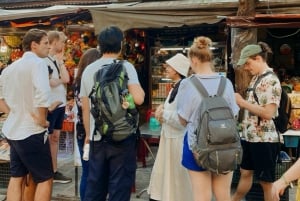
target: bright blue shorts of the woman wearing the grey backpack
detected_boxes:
[181,133,206,172]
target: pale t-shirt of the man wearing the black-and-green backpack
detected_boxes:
[80,58,139,141]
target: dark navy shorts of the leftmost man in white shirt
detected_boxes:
[8,132,53,183]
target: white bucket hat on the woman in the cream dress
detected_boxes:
[166,53,190,77]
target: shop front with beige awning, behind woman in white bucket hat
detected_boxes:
[88,1,238,124]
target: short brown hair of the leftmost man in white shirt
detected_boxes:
[22,29,47,52]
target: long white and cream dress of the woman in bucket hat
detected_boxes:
[148,88,193,201]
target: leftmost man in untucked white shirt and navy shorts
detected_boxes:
[0,29,53,201]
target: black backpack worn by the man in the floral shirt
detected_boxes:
[253,71,292,133]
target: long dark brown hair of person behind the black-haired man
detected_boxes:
[74,48,101,84]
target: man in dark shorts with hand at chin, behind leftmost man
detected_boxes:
[45,31,72,183]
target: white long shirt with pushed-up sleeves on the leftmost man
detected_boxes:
[0,52,50,140]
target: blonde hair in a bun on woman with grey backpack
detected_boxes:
[188,36,213,62]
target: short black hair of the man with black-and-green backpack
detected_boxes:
[98,26,123,54]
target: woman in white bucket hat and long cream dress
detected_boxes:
[148,53,193,201]
